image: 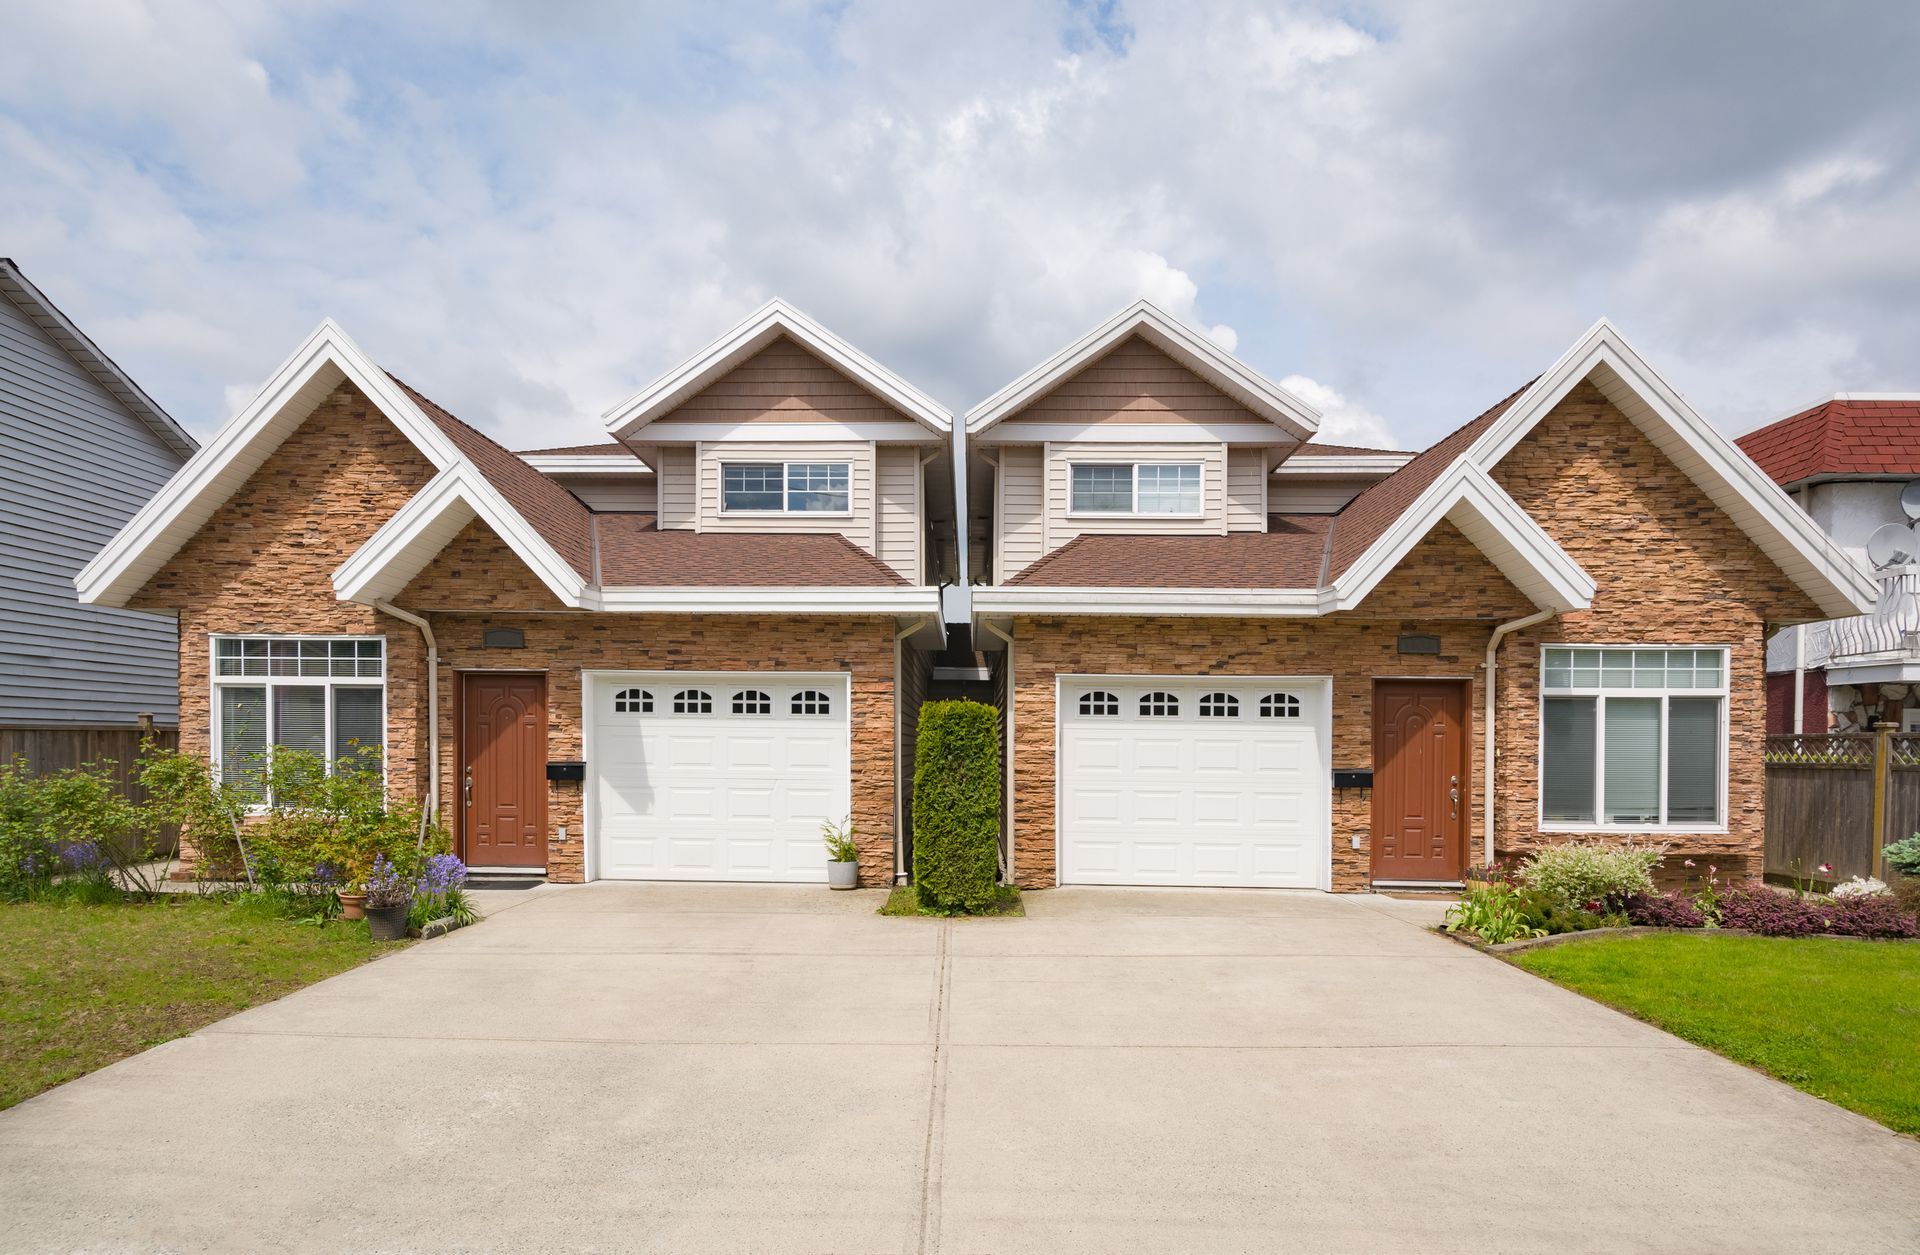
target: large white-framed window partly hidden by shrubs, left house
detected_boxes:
[211,635,386,802]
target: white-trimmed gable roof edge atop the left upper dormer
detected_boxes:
[605,297,954,439]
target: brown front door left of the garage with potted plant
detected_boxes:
[461,672,547,867]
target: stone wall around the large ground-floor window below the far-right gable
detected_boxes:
[1494,384,1822,879]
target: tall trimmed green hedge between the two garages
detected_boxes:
[914,702,1000,912]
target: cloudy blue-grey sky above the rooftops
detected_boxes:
[0,0,1920,447]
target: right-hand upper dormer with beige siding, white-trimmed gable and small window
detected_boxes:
[966,301,1319,583]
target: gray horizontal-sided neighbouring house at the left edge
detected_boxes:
[0,257,196,731]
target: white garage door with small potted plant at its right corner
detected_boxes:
[588,672,851,881]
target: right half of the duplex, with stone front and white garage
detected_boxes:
[966,303,1876,890]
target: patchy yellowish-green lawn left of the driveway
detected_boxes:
[0,896,405,1109]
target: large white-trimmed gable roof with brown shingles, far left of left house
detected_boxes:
[75,319,588,606]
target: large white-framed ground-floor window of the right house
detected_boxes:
[1540,645,1728,831]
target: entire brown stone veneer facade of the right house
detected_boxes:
[1014,384,1820,890]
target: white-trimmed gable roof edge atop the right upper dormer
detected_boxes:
[966,299,1319,439]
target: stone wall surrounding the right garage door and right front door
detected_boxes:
[1014,522,1532,892]
